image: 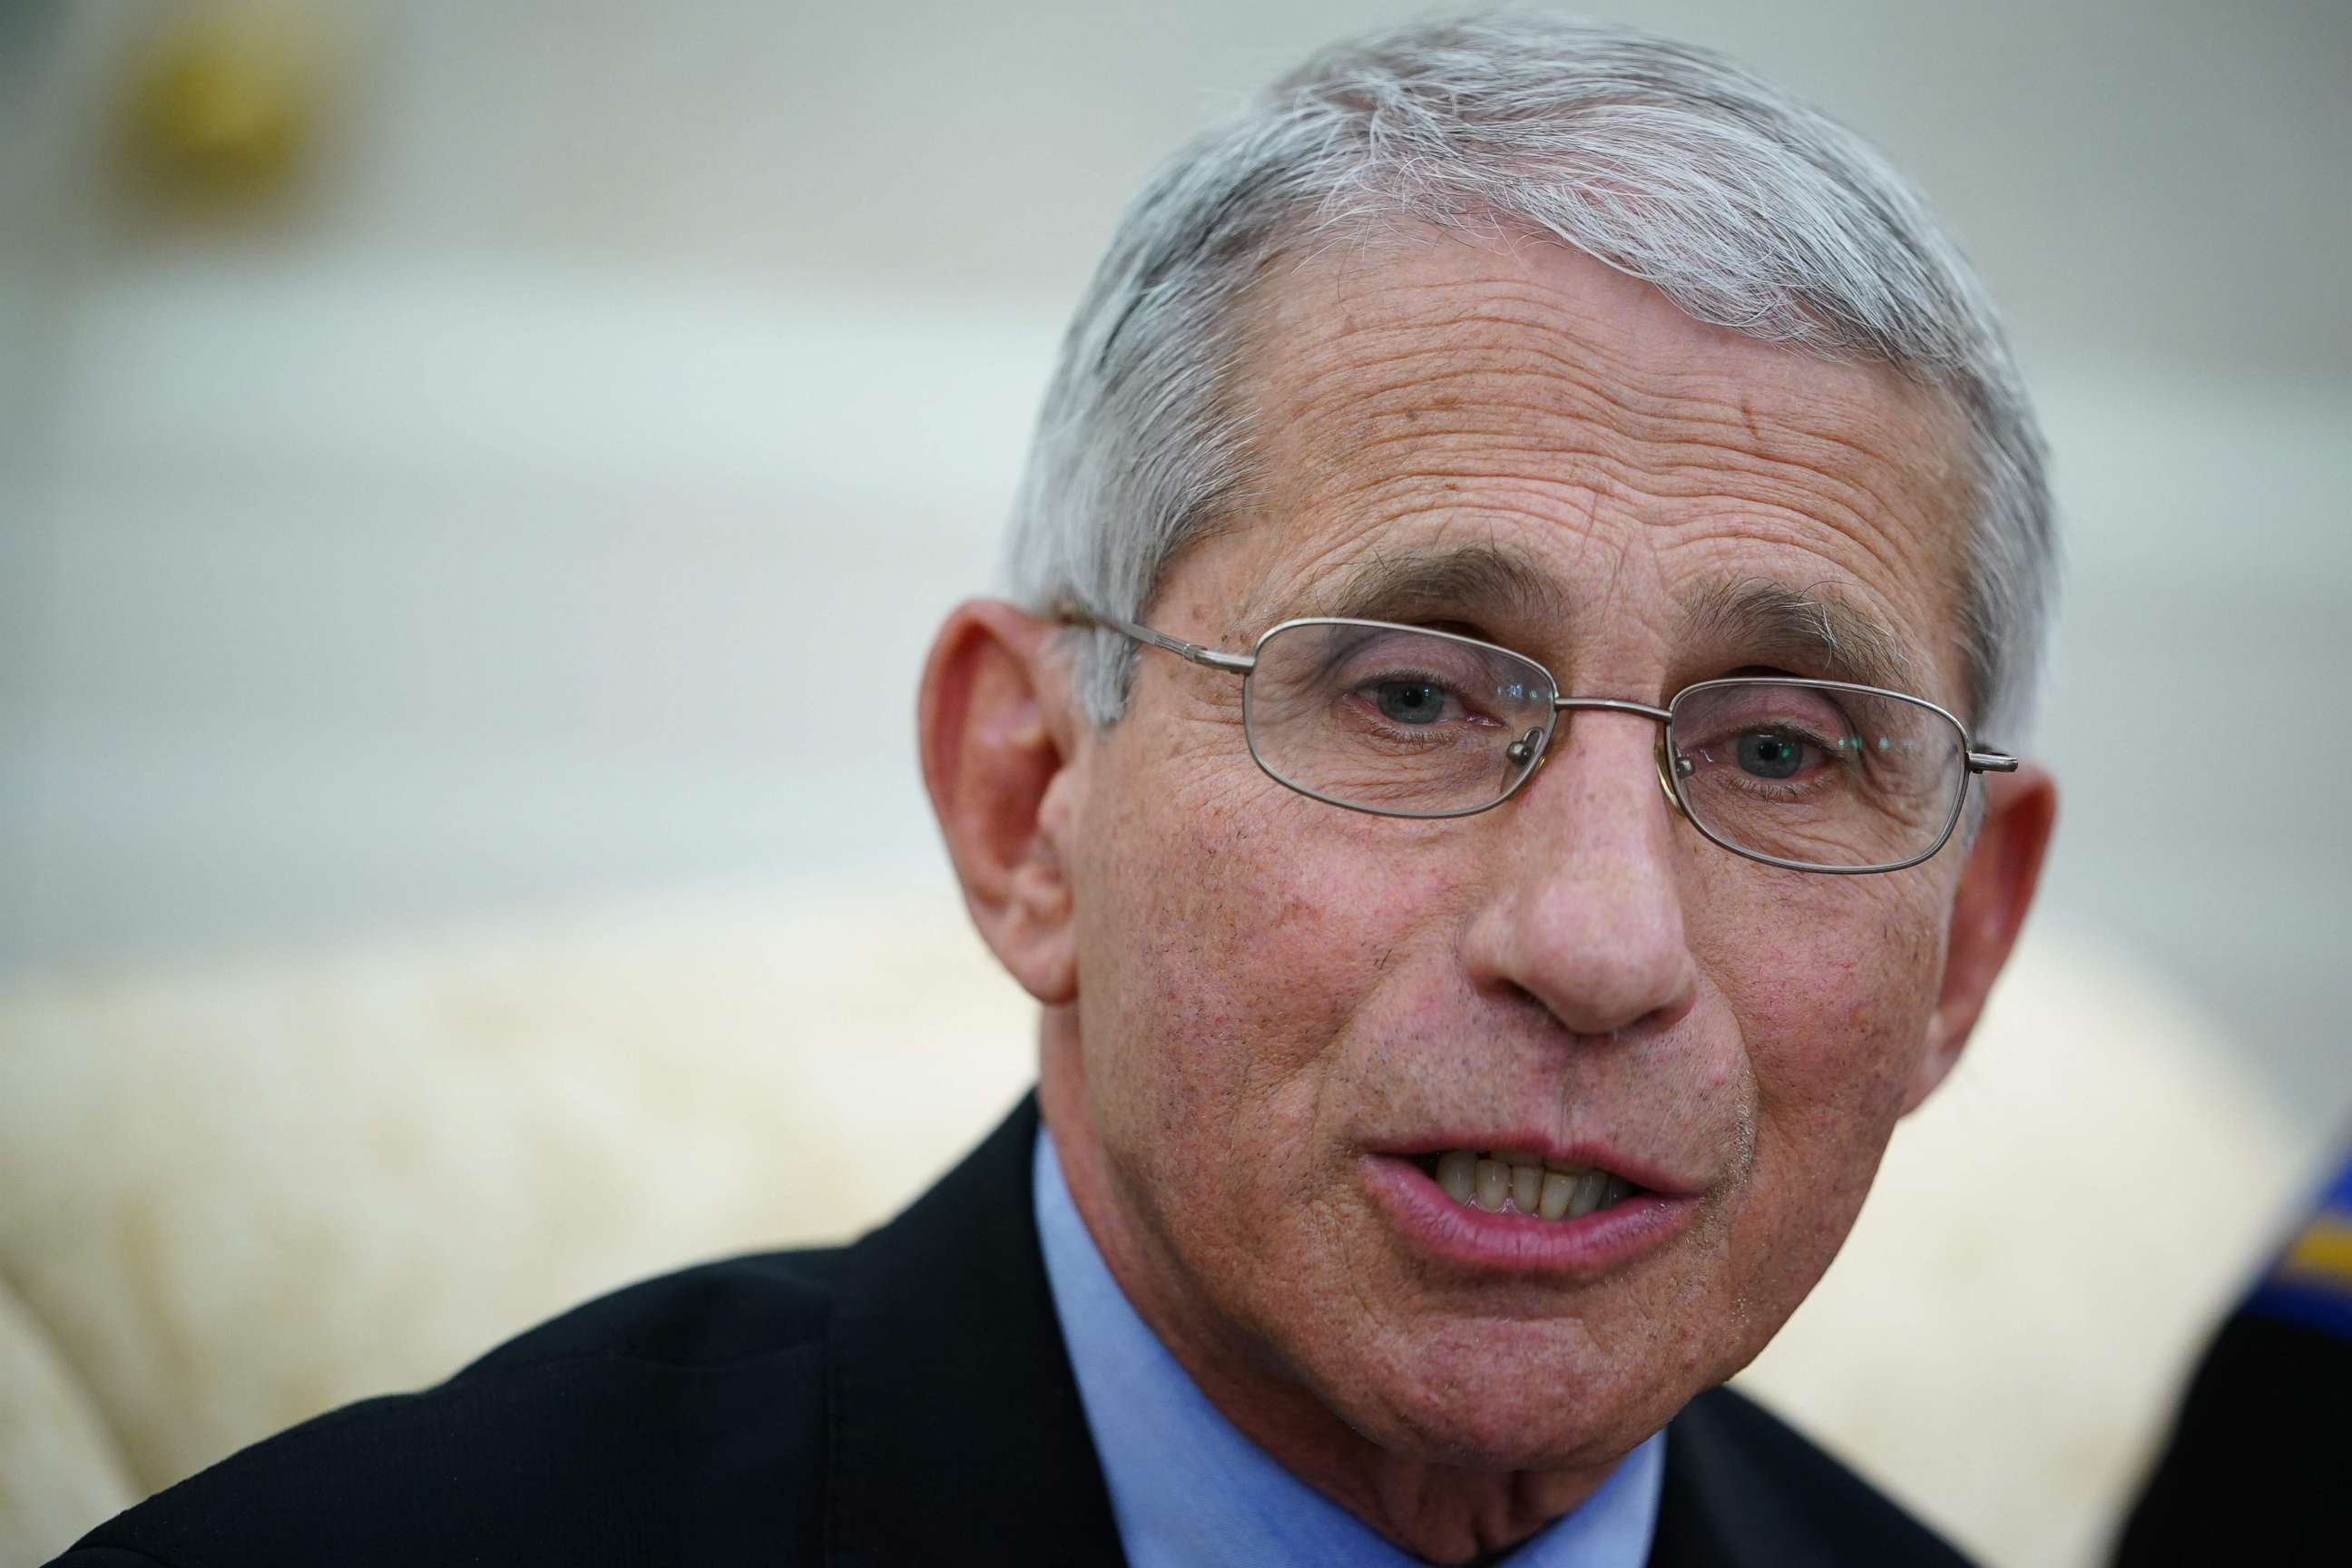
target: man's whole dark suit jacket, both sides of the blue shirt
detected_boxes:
[56,1100,1962,1568]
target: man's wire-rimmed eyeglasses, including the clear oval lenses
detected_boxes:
[1065,613,2018,875]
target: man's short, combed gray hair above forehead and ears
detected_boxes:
[1009,16,2055,733]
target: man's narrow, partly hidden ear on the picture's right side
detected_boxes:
[1903,767,2058,1117]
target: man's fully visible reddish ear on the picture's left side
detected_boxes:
[917,600,1082,1006]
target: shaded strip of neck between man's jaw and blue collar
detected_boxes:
[1037,1029,1613,1563]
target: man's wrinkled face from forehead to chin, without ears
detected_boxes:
[1046,238,1964,1469]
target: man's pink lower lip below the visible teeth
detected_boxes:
[1364,1145,1698,1281]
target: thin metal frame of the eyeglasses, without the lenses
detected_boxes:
[1061,612,2021,877]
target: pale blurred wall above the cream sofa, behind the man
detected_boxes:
[0,0,2352,1128]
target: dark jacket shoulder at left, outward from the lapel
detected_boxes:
[56,1249,847,1568]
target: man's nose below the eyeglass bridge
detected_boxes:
[1463,710,1698,1034]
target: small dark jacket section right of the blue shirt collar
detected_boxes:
[1651,1389,1969,1568]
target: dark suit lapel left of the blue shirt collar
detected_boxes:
[826,1095,1122,1568]
